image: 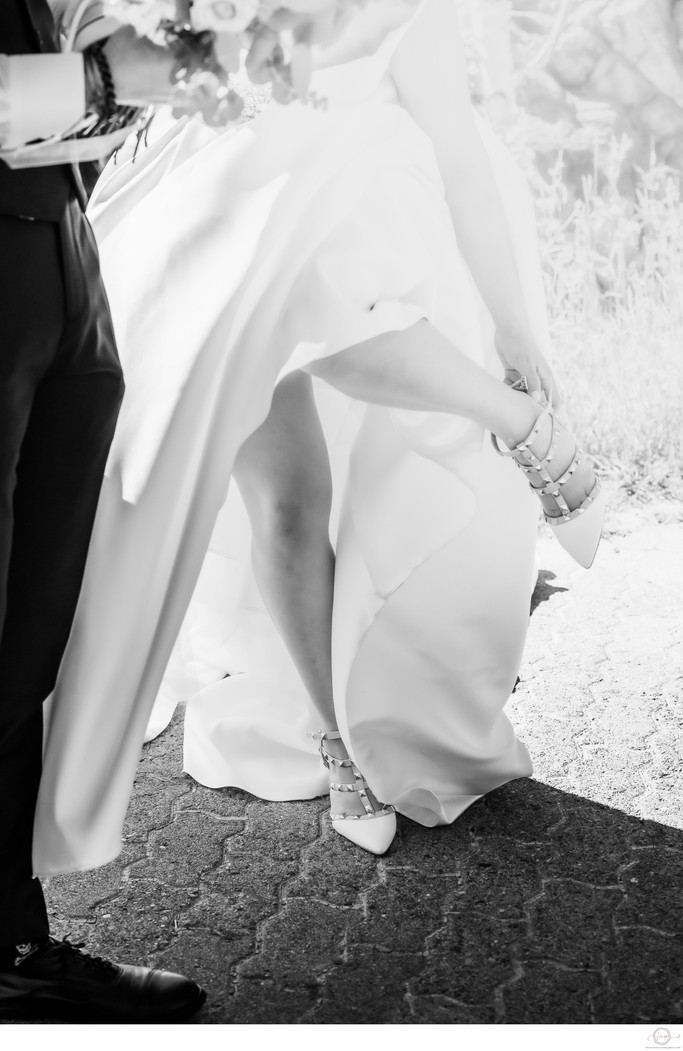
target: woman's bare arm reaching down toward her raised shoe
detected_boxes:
[392,0,553,396]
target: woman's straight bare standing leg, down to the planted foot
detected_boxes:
[234,372,388,813]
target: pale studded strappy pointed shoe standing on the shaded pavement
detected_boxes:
[309,729,396,854]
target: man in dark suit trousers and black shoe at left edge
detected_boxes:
[0,0,205,1022]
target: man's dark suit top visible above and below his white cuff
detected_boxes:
[0,0,78,222]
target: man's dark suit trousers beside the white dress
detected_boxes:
[0,200,123,946]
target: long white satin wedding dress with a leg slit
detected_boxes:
[35,0,546,873]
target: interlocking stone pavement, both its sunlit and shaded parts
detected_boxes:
[37,504,683,1025]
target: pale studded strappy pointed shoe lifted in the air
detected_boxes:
[491,378,606,570]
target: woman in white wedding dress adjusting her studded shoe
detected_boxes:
[35,0,603,873]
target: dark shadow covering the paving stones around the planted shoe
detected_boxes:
[35,721,683,1024]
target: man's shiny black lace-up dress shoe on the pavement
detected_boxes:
[0,937,206,1023]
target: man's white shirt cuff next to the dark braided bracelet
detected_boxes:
[2,54,85,148]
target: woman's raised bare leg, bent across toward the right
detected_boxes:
[308,321,595,511]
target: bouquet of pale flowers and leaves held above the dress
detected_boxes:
[105,0,369,126]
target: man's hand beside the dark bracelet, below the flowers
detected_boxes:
[103,26,175,106]
